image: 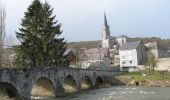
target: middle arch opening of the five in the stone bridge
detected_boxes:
[62,75,78,93]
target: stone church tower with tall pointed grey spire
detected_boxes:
[102,13,110,49]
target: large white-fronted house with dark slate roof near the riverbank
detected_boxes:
[119,41,145,72]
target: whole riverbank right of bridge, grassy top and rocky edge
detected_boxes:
[111,73,170,87]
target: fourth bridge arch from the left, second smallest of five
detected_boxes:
[80,76,92,90]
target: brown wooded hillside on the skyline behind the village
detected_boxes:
[68,37,170,48]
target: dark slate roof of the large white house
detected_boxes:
[120,41,141,50]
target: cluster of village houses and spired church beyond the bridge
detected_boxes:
[65,14,170,72]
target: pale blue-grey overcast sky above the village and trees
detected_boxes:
[1,0,170,44]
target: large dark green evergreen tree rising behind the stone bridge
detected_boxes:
[16,0,66,67]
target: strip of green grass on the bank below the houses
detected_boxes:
[122,72,170,80]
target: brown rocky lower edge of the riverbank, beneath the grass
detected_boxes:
[112,76,170,87]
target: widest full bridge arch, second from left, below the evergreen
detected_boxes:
[31,77,56,97]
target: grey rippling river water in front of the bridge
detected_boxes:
[41,86,170,100]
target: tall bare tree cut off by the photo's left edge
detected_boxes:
[0,0,6,67]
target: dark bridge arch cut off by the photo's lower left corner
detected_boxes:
[0,82,20,100]
